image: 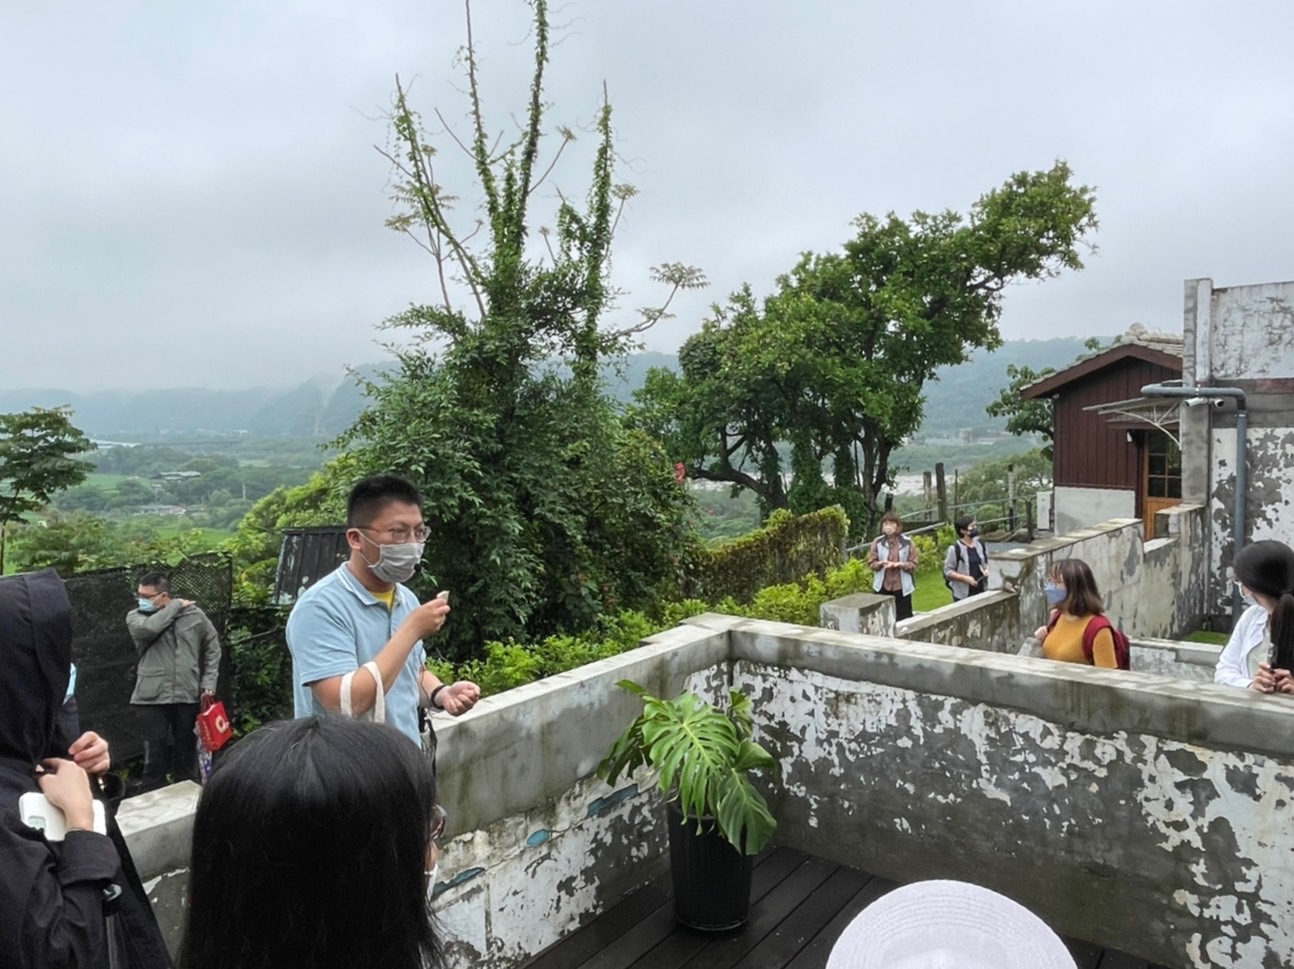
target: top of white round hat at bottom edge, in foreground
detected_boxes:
[827,880,1075,969]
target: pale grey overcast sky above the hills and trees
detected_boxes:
[0,0,1294,392]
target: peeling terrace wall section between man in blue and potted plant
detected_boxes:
[435,616,724,968]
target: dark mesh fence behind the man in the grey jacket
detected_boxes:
[63,552,233,763]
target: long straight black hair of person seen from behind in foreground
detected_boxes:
[179,717,439,969]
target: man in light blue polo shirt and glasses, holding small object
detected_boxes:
[287,475,480,750]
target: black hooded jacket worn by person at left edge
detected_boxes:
[0,569,168,969]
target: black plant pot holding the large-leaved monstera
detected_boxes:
[668,802,753,931]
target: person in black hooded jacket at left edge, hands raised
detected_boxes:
[0,569,171,969]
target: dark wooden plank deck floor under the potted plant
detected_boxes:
[525,847,1163,969]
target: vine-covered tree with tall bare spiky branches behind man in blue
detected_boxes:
[328,0,705,655]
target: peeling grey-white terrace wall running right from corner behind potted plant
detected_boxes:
[732,622,1294,966]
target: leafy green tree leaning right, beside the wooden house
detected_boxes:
[635,162,1097,528]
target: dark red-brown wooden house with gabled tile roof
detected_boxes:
[1021,325,1181,537]
